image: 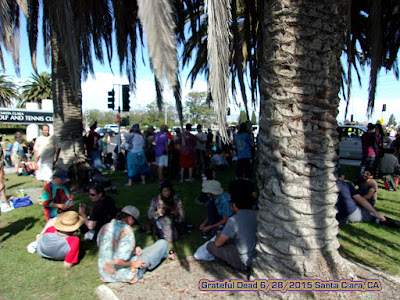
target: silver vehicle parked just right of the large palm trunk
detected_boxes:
[338,125,368,160]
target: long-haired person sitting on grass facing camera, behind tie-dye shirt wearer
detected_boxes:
[147,181,185,242]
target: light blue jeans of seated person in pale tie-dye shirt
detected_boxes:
[137,239,168,279]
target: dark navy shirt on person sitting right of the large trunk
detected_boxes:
[336,180,359,220]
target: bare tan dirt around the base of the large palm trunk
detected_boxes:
[98,258,400,300]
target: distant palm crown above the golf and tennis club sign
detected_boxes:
[20,72,52,107]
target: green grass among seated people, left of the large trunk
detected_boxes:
[0,169,234,299]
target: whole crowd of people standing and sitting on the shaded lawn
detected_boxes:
[0,119,400,283]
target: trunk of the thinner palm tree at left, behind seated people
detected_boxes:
[51,30,83,168]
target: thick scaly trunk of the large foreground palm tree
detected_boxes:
[253,0,347,288]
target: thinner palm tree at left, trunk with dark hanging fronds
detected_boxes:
[27,0,112,165]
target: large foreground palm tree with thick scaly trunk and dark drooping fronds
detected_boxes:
[144,0,400,284]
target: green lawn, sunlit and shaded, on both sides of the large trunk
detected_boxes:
[0,167,400,299]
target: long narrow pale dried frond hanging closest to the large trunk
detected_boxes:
[206,0,231,141]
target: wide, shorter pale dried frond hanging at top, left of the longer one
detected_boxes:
[139,0,178,88]
